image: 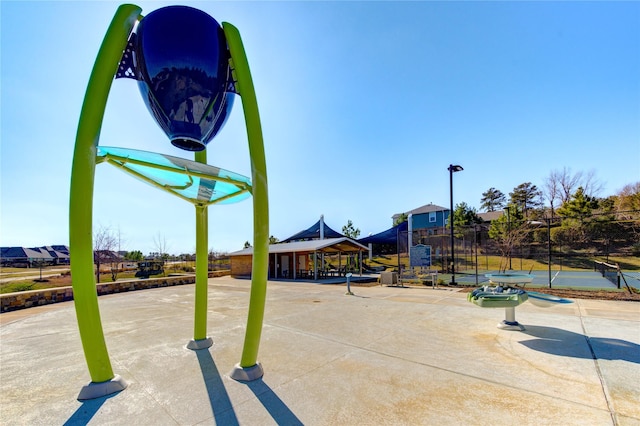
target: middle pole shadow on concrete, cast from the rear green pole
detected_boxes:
[194,349,239,426]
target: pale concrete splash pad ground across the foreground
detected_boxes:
[0,277,640,425]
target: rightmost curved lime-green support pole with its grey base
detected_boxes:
[222,22,269,380]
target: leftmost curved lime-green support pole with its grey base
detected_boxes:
[69,4,142,400]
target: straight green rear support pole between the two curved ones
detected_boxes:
[187,150,213,350]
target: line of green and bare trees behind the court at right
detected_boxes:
[448,167,640,262]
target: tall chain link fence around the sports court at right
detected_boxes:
[384,211,640,273]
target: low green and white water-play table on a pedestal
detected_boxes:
[467,272,572,331]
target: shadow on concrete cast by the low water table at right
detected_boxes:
[520,325,640,364]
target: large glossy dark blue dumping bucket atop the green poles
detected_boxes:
[132,6,235,151]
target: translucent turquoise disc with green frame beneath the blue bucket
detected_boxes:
[97,146,251,205]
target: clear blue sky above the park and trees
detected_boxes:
[0,0,640,254]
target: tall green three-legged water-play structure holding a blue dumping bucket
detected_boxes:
[69,4,269,400]
